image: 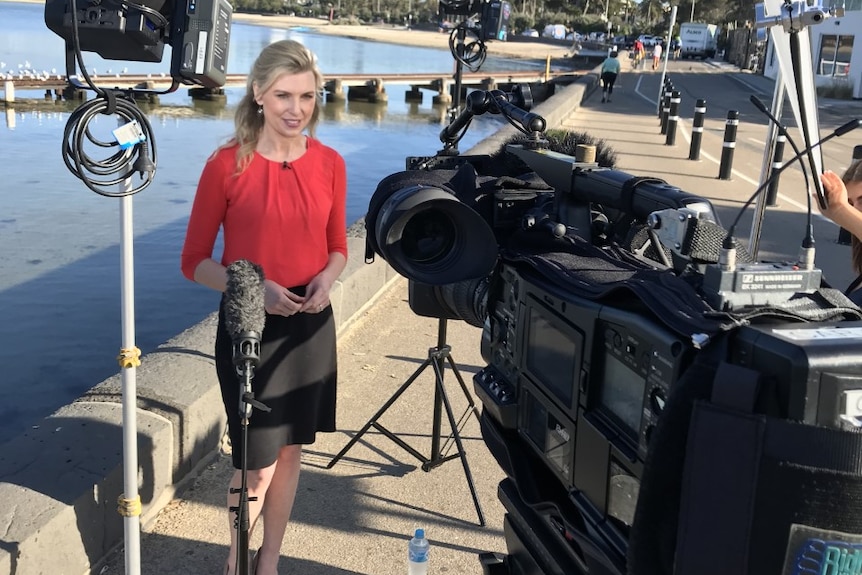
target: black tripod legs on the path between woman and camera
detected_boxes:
[326,318,485,527]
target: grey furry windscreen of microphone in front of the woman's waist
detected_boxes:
[224,260,266,339]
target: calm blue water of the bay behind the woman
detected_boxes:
[0,3,548,442]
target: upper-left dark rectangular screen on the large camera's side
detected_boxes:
[526,307,582,409]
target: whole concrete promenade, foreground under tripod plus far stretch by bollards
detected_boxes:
[96,62,862,575]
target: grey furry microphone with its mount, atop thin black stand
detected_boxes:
[224,260,266,418]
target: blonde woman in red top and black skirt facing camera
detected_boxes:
[181,40,347,575]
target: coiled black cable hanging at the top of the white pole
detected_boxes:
[62,0,158,197]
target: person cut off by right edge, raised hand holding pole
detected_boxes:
[818,165,862,306]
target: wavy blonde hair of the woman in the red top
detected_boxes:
[228,40,323,173]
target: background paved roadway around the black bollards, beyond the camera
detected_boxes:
[566,55,862,288]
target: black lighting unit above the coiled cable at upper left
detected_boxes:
[45,0,233,88]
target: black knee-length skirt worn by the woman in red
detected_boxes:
[215,288,337,469]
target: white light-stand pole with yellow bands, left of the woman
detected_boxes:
[118,118,141,575]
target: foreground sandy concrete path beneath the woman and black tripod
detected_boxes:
[100,279,505,575]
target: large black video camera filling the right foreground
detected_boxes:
[366,83,862,575]
